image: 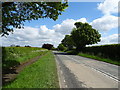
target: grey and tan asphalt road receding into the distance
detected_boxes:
[53,51,120,88]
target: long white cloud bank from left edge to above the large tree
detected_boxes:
[2,18,87,47]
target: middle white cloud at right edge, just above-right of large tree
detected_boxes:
[90,15,118,31]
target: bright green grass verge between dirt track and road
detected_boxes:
[3,51,59,88]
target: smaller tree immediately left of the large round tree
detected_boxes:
[61,35,74,50]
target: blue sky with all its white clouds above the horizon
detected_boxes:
[0,0,119,47]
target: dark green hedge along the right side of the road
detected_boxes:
[82,44,120,61]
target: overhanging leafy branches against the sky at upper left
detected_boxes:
[1,0,68,36]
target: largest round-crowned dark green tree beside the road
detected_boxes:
[71,22,101,50]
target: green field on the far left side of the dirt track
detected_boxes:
[2,47,47,69]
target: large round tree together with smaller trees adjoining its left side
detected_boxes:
[57,22,101,51]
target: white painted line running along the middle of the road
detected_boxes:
[65,55,120,82]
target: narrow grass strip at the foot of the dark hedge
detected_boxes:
[78,53,120,65]
